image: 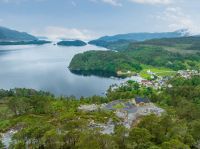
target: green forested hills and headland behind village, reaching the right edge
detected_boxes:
[69,36,200,76]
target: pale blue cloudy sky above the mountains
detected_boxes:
[0,0,200,40]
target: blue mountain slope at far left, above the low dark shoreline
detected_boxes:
[0,27,38,42]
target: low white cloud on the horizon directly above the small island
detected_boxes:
[32,26,96,40]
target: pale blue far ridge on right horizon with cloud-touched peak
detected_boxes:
[89,29,190,47]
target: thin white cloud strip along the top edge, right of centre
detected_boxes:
[129,0,172,5]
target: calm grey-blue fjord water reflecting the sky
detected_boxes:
[0,44,123,97]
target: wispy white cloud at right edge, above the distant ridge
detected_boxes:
[157,7,200,34]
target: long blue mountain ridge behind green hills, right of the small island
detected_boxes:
[88,29,191,50]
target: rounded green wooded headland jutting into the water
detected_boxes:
[69,51,142,76]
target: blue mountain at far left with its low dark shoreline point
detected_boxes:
[0,27,51,45]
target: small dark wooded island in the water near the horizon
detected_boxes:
[57,40,87,47]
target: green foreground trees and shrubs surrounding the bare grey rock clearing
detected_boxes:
[0,76,200,149]
